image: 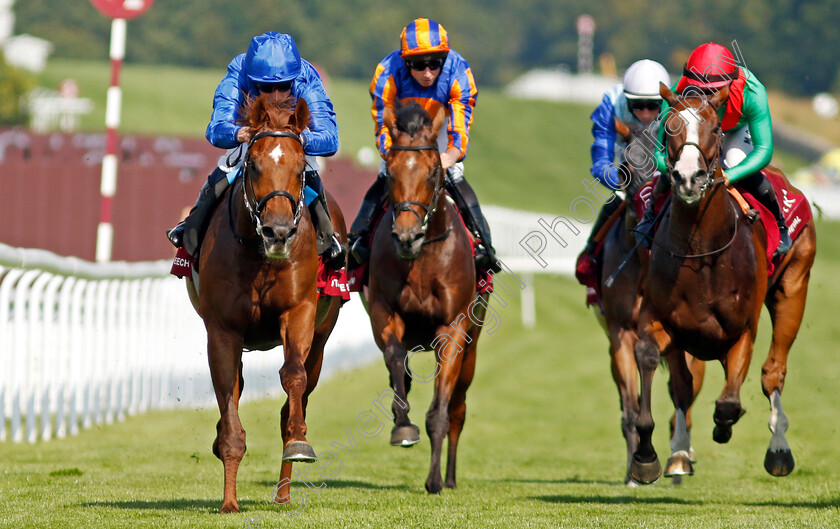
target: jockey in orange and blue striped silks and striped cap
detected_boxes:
[350,18,498,271]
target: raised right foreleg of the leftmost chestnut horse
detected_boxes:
[280,303,316,462]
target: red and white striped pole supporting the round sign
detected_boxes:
[96,18,126,263]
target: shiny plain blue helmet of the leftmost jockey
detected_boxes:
[245,31,300,83]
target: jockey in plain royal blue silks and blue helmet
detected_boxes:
[167,31,346,268]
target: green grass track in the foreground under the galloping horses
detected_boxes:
[0,217,840,528]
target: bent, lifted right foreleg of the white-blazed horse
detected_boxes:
[712,329,755,443]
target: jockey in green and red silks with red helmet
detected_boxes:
[636,42,792,254]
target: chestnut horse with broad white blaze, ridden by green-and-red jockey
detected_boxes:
[630,85,816,483]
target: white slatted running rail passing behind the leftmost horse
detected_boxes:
[0,244,380,443]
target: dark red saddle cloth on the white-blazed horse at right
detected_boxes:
[633,168,812,276]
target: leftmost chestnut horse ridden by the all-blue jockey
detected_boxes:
[189,92,345,512]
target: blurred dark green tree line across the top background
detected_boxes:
[13,0,840,95]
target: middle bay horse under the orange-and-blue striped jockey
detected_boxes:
[367,102,489,493]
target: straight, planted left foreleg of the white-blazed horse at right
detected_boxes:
[630,319,670,485]
